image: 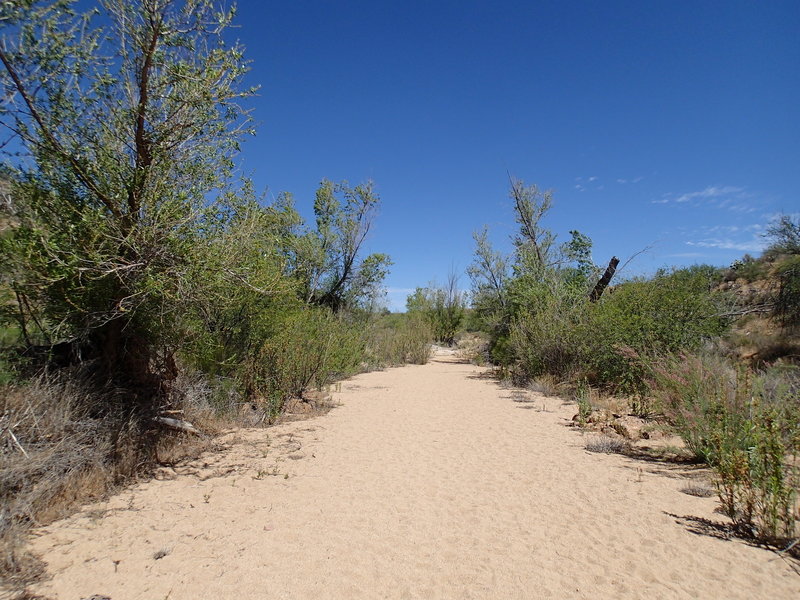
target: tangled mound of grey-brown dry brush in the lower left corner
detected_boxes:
[0,377,152,585]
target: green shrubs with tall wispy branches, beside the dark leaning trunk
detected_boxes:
[468,179,730,396]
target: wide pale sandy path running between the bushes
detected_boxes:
[25,356,800,600]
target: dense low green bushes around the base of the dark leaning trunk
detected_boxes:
[510,266,727,400]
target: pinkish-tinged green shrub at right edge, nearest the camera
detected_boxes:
[650,354,800,540]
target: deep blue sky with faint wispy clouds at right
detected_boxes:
[228,0,800,308]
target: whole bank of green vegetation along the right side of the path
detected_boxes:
[469,181,800,543]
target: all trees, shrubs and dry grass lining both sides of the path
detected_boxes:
[0,0,800,584]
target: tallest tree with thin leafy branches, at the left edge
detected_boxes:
[0,0,253,386]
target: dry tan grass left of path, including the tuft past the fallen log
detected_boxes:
[0,377,239,594]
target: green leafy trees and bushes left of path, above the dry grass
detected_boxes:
[0,0,406,407]
